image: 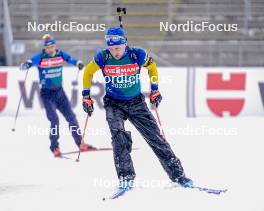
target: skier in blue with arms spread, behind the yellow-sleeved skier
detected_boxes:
[20,34,95,157]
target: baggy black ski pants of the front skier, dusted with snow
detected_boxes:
[104,94,185,182]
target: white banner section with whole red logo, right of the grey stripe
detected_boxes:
[194,67,264,117]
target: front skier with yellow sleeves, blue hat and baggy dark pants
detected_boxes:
[82,27,193,189]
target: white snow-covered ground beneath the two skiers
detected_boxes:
[0,116,264,211]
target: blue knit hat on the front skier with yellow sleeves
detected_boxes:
[105,26,127,46]
